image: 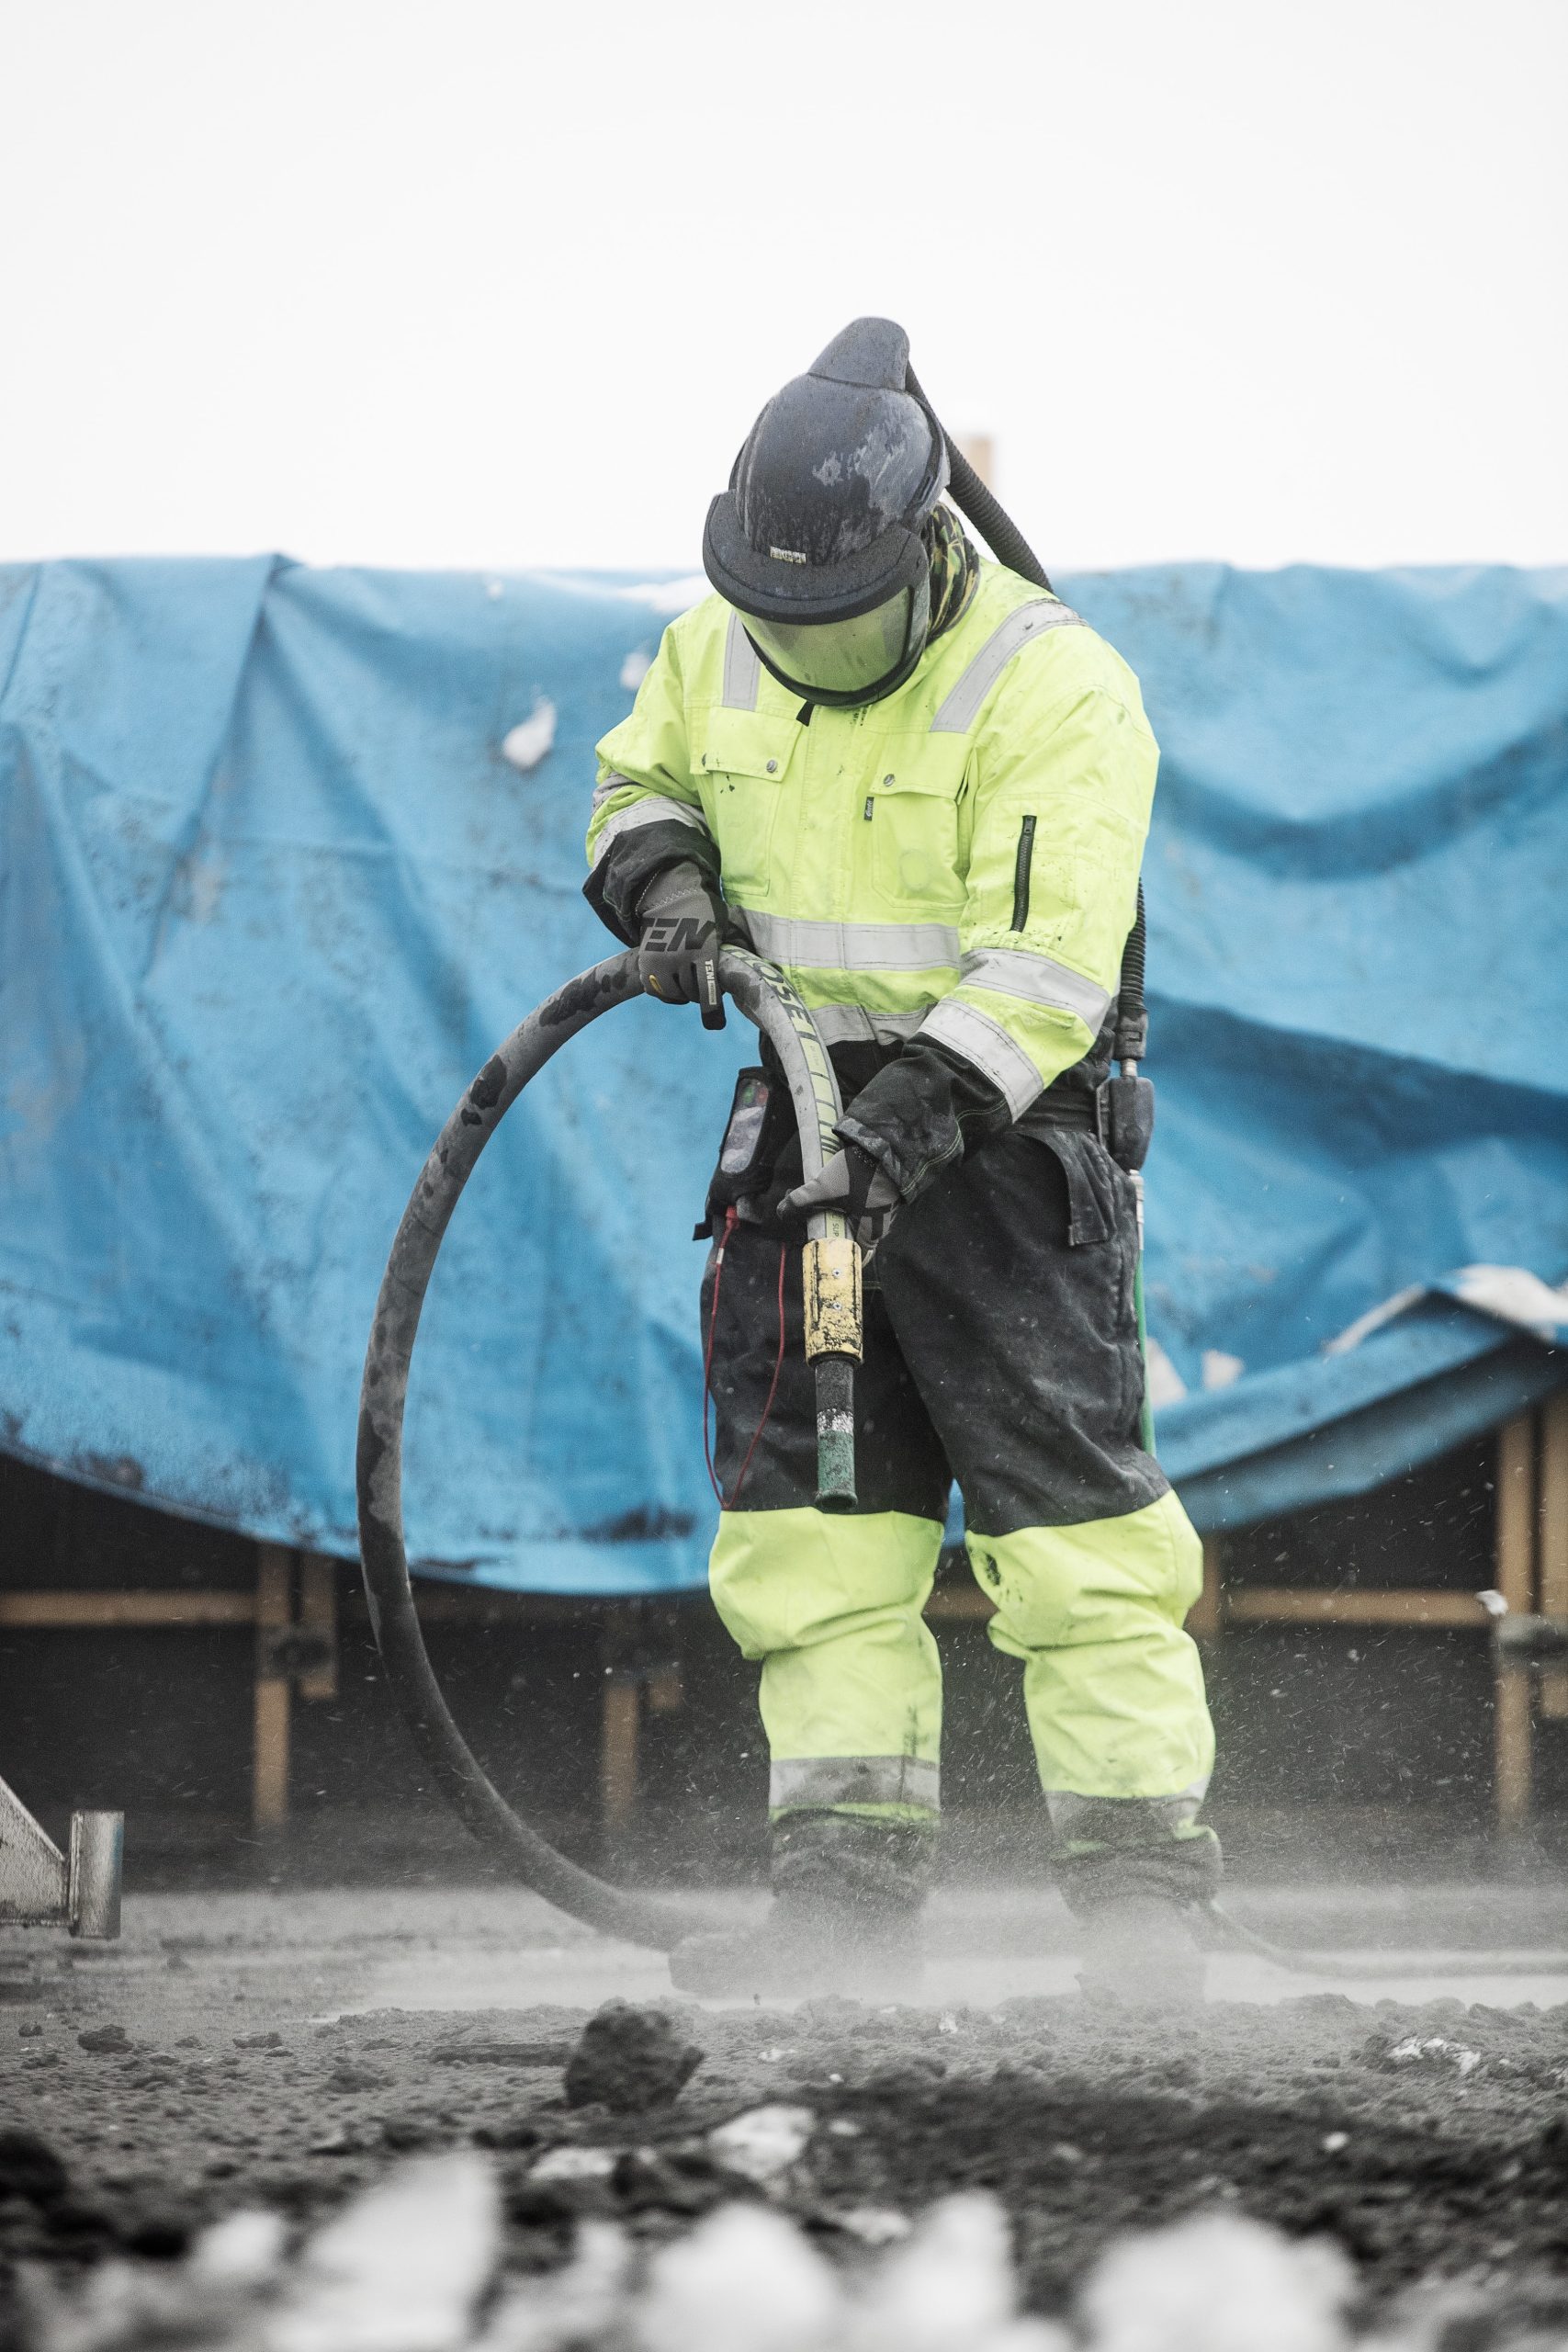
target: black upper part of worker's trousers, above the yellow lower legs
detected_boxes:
[703,1122,1166,1536]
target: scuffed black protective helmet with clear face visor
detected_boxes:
[703,318,947,706]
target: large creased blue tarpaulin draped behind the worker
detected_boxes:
[0,558,1568,1592]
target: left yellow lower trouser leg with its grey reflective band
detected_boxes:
[707,1510,942,1820]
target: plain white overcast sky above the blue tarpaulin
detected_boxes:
[0,0,1568,570]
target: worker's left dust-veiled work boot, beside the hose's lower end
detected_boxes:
[670,1814,933,2002]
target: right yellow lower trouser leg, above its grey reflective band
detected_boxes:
[968,1494,1213,1797]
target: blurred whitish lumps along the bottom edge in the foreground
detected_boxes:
[7,2152,1568,2352]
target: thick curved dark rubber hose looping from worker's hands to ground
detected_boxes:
[357,948,840,1952]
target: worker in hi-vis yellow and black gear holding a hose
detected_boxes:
[588,320,1220,2002]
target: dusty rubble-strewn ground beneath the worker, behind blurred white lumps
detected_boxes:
[0,1874,1568,2334]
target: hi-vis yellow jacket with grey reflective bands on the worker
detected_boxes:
[588,564,1159,1117]
